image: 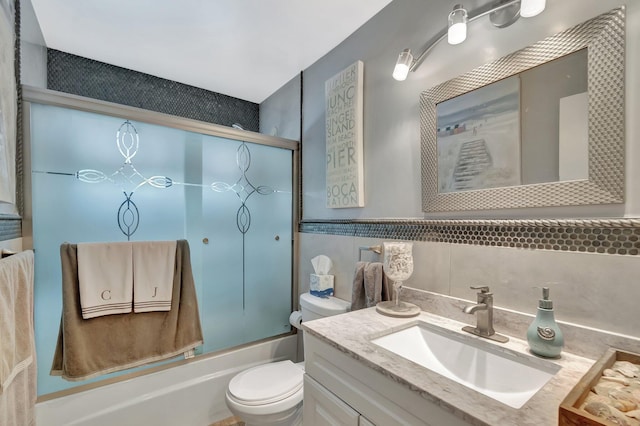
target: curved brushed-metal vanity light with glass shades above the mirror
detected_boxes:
[393,0,546,81]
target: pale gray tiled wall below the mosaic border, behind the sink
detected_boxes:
[299,233,640,337]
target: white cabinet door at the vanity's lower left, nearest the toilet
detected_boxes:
[303,374,360,426]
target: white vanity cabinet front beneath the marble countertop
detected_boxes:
[304,332,467,426]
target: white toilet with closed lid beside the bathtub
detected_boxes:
[226,293,351,426]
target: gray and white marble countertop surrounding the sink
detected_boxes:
[303,308,595,426]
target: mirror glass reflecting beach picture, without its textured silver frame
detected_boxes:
[436,49,589,193]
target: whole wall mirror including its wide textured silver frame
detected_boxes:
[420,7,625,212]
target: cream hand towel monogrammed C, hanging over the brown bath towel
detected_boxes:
[77,242,133,319]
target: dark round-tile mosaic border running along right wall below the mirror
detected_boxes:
[299,218,640,256]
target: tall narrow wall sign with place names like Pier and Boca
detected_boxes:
[325,61,364,208]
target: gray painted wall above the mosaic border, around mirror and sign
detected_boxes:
[262,0,640,219]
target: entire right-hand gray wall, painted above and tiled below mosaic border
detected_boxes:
[258,0,640,337]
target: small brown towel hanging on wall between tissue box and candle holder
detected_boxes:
[351,262,391,311]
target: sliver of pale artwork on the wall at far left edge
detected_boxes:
[0,0,17,214]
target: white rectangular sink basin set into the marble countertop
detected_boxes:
[371,321,560,408]
